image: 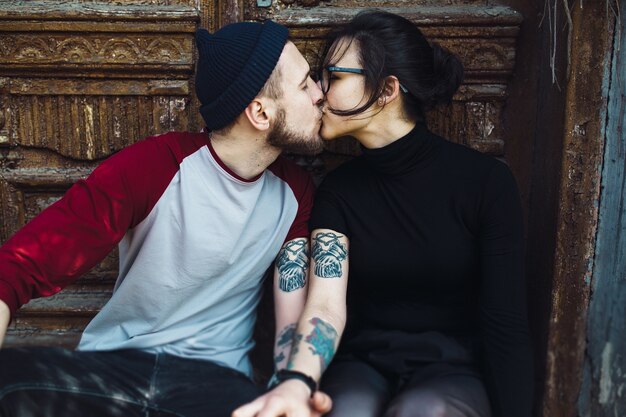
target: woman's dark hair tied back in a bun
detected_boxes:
[320,10,463,121]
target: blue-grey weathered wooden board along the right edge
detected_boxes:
[578,4,626,417]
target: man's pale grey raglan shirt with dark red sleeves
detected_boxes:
[0,133,314,375]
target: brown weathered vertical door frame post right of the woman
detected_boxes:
[542,2,614,417]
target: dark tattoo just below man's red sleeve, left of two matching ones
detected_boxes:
[276,239,309,292]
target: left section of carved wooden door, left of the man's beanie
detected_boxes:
[0,0,199,346]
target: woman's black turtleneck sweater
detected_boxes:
[310,124,532,417]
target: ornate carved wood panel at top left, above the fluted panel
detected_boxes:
[0,1,198,79]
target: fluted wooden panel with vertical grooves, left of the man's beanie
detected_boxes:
[0,78,189,160]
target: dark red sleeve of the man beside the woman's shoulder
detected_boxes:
[269,157,315,242]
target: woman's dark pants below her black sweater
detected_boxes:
[321,331,491,417]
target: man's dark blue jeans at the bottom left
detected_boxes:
[0,348,262,417]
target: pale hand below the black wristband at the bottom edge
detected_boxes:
[232,379,332,417]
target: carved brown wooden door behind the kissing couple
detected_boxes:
[0,0,521,352]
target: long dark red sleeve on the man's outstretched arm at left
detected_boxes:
[0,134,207,312]
